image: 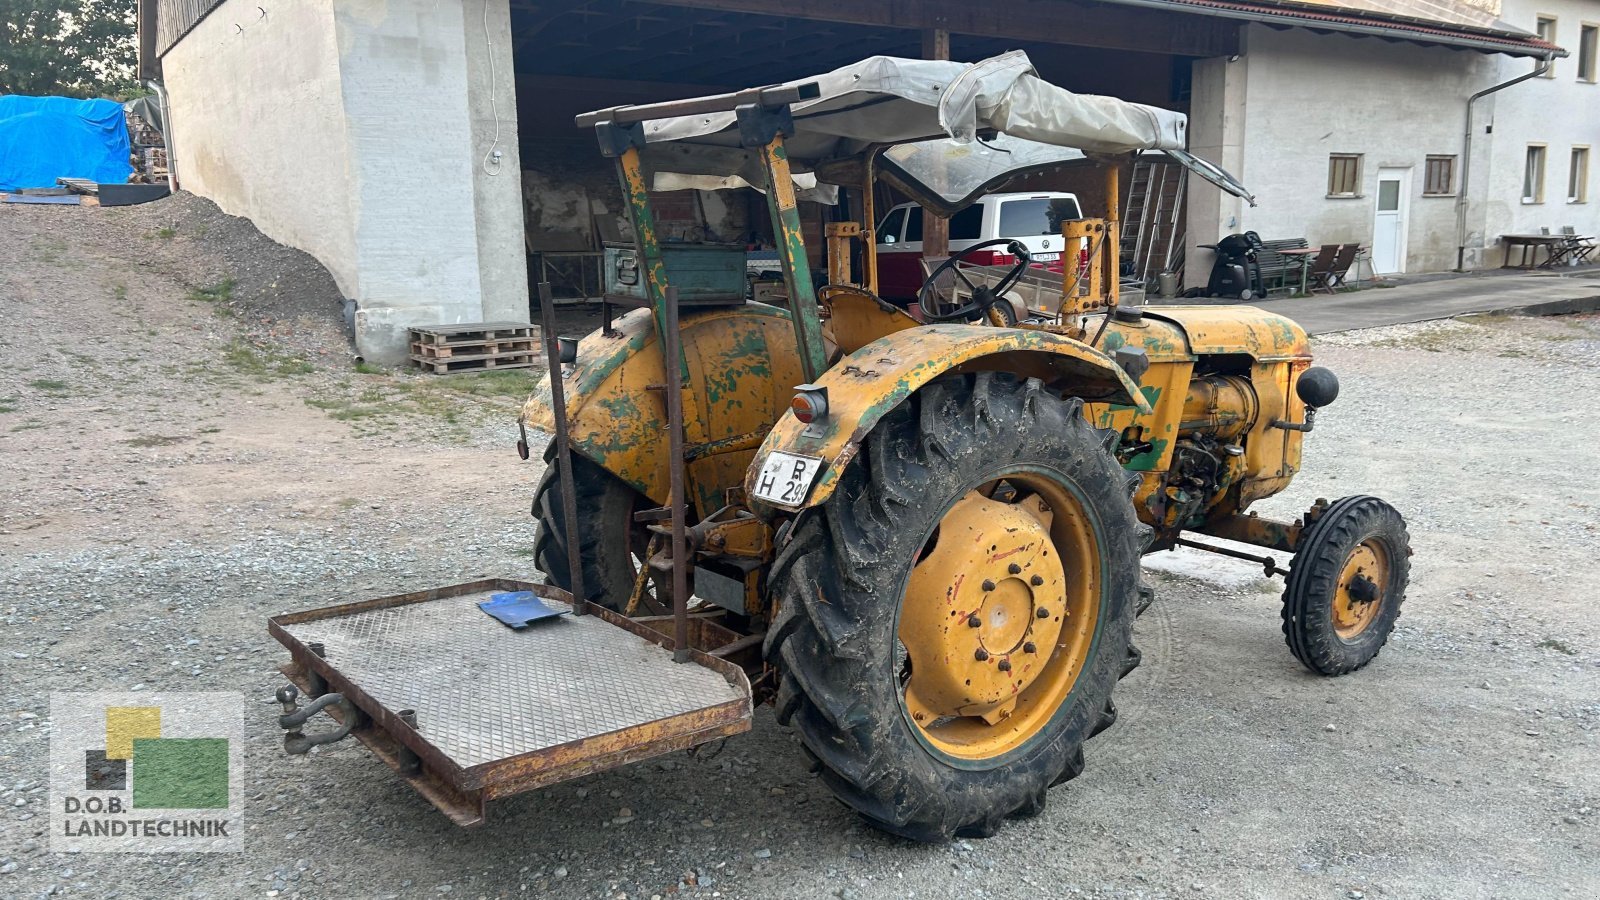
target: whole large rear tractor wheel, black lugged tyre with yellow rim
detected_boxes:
[766,373,1149,841]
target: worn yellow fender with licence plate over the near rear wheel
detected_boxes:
[744,325,1150,511]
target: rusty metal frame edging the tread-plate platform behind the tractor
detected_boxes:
[267,578,752,826]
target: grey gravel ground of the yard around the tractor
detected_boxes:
[0,197,1600,900]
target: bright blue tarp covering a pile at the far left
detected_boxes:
[0,94,133,192]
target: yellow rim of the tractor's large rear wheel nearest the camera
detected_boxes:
[899,474,1101,761]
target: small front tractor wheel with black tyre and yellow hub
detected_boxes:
[1283,496,1411,676]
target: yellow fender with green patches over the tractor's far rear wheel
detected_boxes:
[522,303,805,514]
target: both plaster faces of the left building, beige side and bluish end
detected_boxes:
[163,0,528,364]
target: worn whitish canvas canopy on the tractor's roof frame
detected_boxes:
[579,51,1253,211]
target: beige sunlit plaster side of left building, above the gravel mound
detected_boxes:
[162,0,362,296]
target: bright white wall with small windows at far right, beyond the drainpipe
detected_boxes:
[1467,0,1600,266]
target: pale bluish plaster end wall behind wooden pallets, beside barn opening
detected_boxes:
[334,0,526,362]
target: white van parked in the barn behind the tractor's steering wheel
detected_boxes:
[875,191,1083,299]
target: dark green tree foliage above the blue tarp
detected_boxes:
[0,0,138,96]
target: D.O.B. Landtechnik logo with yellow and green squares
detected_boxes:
[50,692,243,854]
